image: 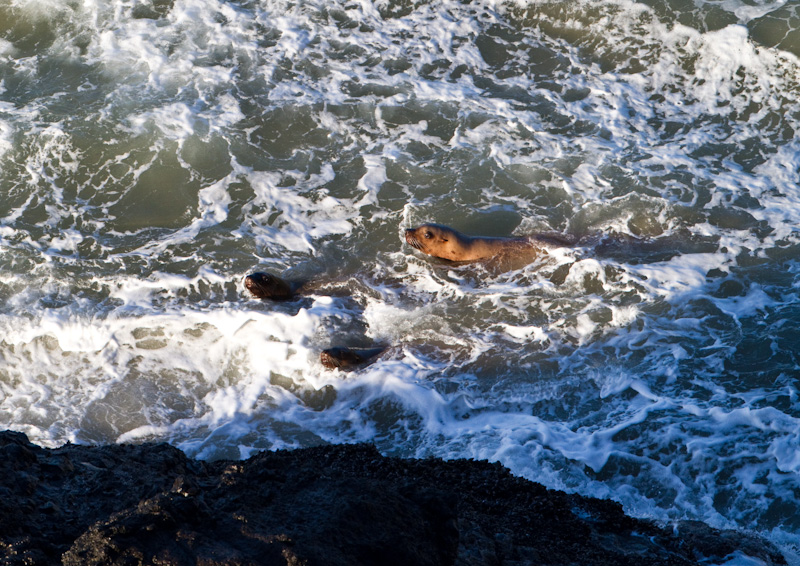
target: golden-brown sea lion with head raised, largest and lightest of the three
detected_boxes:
[405,224,574,262]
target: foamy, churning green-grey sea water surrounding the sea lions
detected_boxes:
[0,0,800,560]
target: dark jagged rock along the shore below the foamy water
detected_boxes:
[0,432,786,566]
